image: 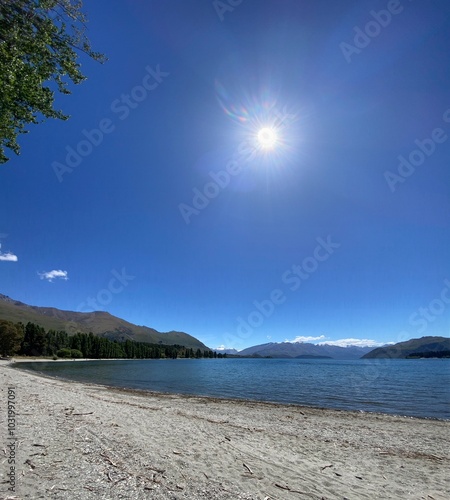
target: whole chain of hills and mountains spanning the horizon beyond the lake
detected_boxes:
[0,294,450,359]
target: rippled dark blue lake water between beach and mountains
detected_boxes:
[16,358,450,420]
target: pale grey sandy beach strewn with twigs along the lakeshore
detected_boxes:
[0,361,450,500]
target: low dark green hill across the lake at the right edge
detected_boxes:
[363,337,450,359]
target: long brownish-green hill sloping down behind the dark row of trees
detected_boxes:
[0,294,208,349]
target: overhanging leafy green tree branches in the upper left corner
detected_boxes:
[0,0,105,163]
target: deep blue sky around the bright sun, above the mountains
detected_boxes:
[0,0,450,349]
